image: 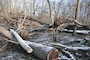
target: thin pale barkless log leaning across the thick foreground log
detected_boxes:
[10,29,33,53]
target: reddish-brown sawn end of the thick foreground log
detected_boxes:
[47,49,59,60]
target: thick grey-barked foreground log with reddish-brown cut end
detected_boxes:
[25,41,59,60]
